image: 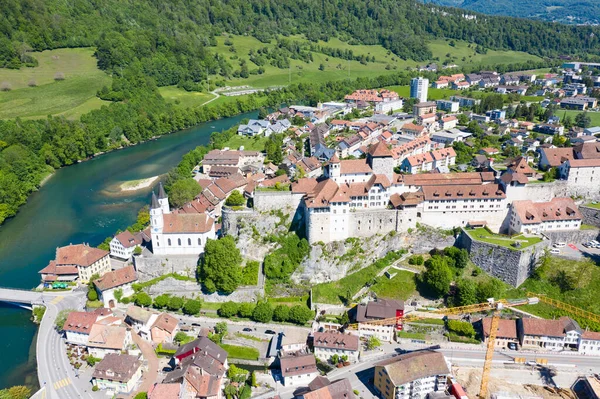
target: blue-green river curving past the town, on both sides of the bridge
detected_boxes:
[0,113,256,388]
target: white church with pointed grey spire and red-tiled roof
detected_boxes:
[150,183,216,255]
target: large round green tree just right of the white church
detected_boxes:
[198,236,242,294]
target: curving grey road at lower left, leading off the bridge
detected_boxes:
[36,290,101,399]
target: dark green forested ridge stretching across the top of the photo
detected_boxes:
[0,0,600,76]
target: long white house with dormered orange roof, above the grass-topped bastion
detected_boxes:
[509,197,582,234]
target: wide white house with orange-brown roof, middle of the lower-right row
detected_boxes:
[517,317,582,351]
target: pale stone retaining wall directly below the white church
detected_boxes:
[133,255,199,282]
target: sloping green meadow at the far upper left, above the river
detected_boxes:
[0,48,110,119]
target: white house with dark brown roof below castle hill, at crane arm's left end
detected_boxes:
[350,298,404,342]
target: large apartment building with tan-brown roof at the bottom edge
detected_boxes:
[374,350,450,399]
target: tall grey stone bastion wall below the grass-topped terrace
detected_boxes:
[456,230,550,287]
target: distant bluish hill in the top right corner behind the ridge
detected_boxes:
[423,0,600,24]
